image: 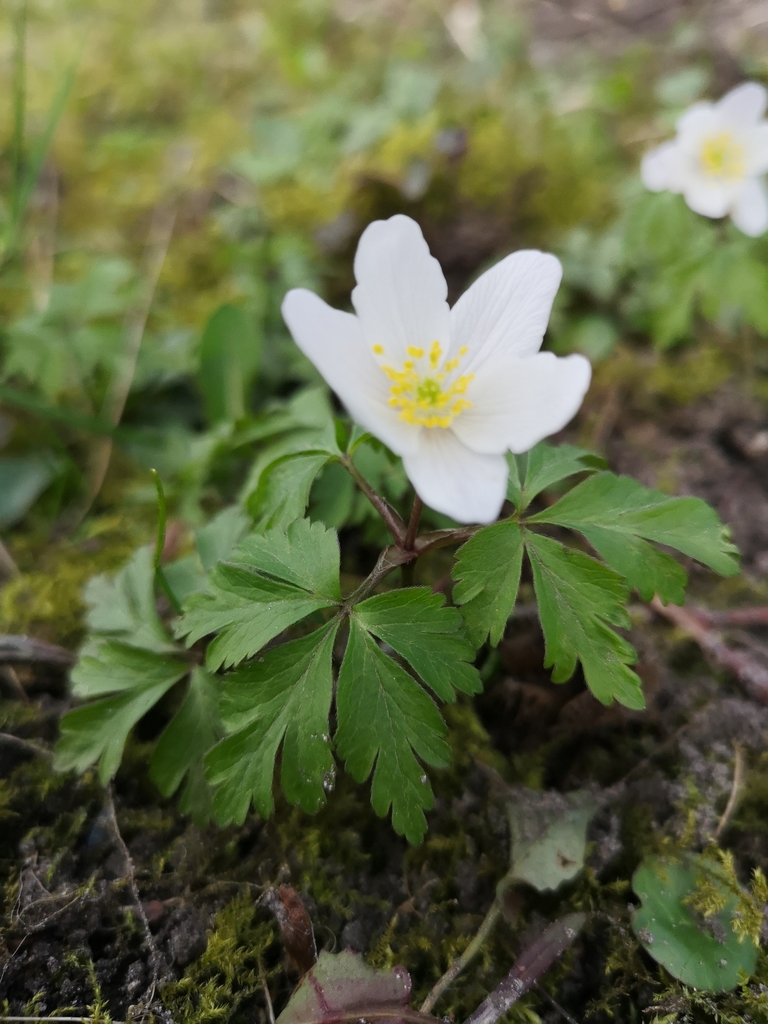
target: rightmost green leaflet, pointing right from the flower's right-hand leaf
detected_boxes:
[529,473,738,603]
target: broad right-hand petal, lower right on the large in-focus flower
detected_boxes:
[452,352,592,455]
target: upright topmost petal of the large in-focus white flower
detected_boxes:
[352,214,451,367]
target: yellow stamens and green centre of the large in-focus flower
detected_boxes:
[374,341,474,427]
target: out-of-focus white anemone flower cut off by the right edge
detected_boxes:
[640,82,768,238]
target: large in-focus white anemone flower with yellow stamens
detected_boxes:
[283,215,591,523]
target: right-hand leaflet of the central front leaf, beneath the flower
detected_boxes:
[354,587,482,702]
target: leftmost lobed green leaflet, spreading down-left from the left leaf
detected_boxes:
[54,640,188,784]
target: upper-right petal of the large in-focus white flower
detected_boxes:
[451,249,562,374]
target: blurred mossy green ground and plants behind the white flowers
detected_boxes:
[0,0,768,552]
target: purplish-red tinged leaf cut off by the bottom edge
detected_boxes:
[278,949,411,1024]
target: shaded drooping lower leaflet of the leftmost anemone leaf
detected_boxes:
[150,669,223,824]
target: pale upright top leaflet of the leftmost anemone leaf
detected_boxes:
[84,546,173,651]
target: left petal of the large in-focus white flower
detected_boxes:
[283,288,419,455]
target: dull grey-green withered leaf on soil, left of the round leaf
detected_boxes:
[509,786,598,892]
